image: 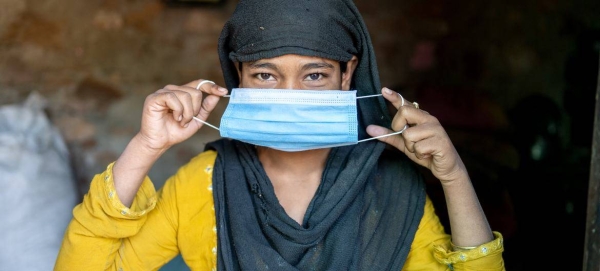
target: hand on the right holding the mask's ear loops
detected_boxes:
[367,88,468,183]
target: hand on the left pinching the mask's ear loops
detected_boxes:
[136,79,227,152]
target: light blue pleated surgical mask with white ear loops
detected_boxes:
[196,88,406,152]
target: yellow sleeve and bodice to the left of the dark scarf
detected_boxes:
[54,152,216,271]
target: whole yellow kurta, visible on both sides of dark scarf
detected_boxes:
[54,151,504,271]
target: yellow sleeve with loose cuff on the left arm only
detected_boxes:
[54,163,161,271]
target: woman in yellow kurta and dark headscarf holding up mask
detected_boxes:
[55,0,504,270]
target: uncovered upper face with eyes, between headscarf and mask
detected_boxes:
[240,55,358,90]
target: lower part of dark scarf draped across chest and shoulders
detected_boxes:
[207,139,425,271]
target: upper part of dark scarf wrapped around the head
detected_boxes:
[219,0,391,139]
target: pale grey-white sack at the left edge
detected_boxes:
[0,93,78,271]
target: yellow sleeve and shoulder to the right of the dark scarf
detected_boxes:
[402,197,505,271]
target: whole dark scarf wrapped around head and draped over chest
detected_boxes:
[211,0,425,271]
